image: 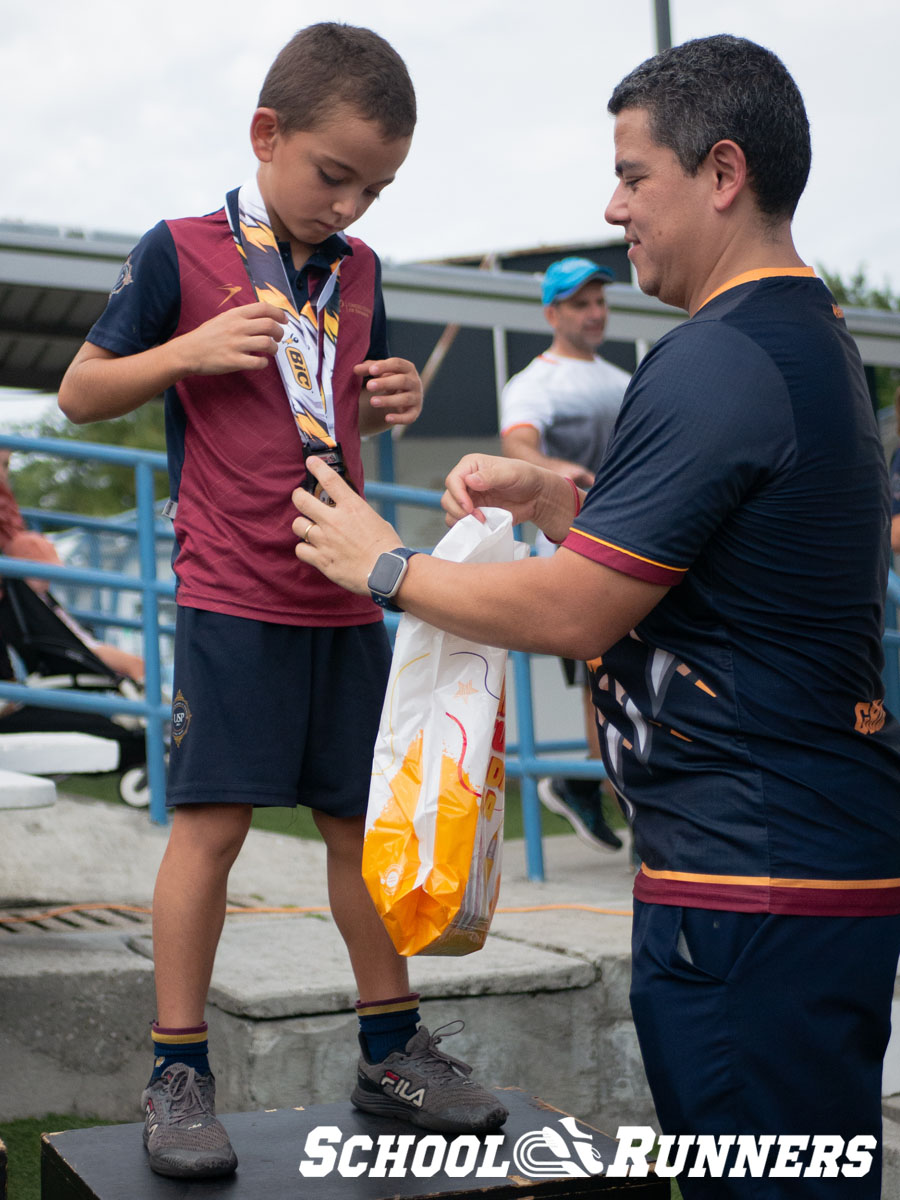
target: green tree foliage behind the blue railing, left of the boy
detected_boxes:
[11,402,169,516]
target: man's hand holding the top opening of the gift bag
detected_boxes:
[440,454,575,539]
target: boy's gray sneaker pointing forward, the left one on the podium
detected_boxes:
[140,1062,238,1180]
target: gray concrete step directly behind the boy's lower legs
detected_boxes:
[0,913,654,1128]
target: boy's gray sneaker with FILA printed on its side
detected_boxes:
[350,1021,509,1133]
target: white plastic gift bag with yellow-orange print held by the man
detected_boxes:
[362,509,528,955]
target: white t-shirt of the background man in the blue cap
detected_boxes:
[500,353,631,472]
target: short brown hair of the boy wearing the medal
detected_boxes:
[259,22,415,140]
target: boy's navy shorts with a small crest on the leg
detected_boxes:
[166,607,391,817]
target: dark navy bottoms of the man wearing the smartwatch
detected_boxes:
[631,900,900,1200]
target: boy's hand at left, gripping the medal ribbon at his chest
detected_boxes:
[179,300,288,374]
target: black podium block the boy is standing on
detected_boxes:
[41,1088,670,1200]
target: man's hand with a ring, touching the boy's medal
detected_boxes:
[290,457,403,595]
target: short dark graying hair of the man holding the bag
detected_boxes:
[608,34,811,218]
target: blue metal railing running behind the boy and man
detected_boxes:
[0,434,900,880]
